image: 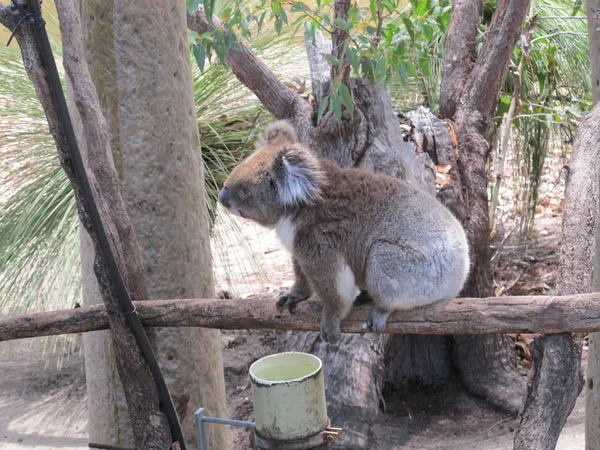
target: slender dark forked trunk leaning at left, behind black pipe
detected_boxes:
[0,0,172,450]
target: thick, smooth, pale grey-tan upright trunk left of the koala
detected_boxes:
[81,0,227,449]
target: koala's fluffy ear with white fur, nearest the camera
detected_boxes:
[273,149,325,206]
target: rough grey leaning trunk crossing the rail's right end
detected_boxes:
[515,105,600,450]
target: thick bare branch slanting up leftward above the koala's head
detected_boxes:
[187,8,312,132]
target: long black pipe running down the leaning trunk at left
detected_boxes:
[25,0,186,450]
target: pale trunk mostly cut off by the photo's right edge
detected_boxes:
[585,0,600,450]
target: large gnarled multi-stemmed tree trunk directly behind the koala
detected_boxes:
[188,0,528,449]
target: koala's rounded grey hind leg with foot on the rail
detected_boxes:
[363,242,436,333]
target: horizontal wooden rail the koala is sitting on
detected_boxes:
[0,293,600,342]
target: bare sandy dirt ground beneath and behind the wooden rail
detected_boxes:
[0,214,585,450]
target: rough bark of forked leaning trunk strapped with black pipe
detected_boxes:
[0,0,171,449]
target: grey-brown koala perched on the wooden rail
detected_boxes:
[219,121,470,345]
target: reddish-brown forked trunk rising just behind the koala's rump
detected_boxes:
[433,0,529,413]
